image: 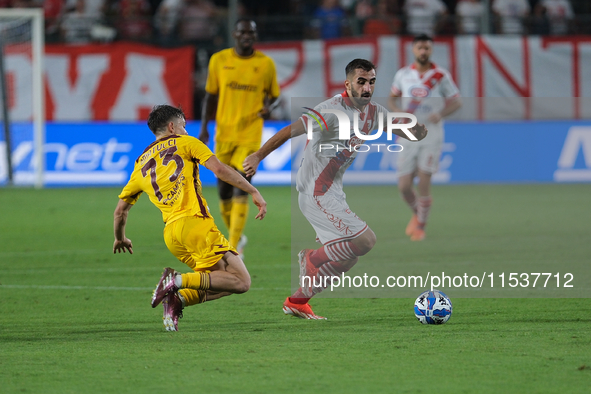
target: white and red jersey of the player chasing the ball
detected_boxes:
[296,92,388,198]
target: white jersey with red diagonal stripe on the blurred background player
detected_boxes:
[391,63,460,142]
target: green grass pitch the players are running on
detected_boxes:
[0,185,591,394]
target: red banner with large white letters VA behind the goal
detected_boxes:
[44,43,195,121]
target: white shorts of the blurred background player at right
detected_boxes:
[397,141,443,176]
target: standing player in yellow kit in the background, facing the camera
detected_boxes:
[199,19,280,255]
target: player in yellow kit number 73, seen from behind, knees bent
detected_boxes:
[113,105,267,331]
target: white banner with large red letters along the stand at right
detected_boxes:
[258,36,591,120]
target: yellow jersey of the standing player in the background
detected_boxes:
[205,48,280,144]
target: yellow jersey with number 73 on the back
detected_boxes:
[119,135,213,224]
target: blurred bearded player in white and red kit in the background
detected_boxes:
[390,34,462,241]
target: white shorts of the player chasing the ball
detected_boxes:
[298,193,368,245]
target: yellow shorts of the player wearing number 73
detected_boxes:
[164,216,238,271]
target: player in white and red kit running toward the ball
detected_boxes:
[243,59,427,319]
